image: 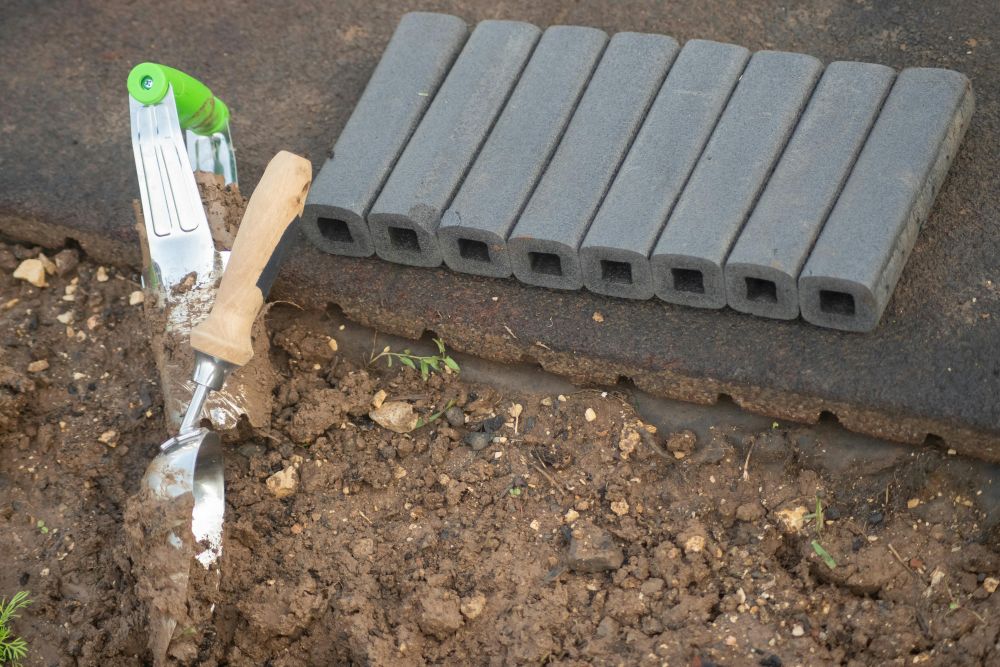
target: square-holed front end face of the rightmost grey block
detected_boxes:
[799,275,886,333]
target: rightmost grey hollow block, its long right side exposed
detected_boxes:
[799,68,975,331]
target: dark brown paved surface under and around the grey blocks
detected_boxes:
[0,0,1000,460]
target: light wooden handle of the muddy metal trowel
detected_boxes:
[191,151,312,366]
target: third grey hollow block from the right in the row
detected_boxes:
[650,51,823,308]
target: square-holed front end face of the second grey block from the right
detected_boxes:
[725,262,799,320]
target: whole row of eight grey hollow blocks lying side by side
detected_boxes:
[303,13,973,331]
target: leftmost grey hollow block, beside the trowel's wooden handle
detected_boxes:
[302,12,469,257]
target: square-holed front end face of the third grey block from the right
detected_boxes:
[650,253,726,308]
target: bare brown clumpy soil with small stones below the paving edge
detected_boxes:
[0,237,1000,667]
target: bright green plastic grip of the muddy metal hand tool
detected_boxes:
[128,63,229,136]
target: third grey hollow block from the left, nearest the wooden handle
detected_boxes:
[438,26,608,278]
